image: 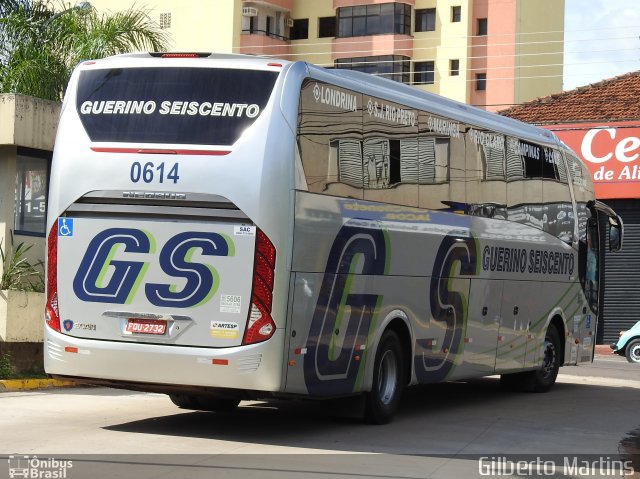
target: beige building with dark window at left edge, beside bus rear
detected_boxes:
[0,94,61,372]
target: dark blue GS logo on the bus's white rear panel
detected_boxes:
[73,228,234,308]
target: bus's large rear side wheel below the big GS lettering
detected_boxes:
[364,330,405,424]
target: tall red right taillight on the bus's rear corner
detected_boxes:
[242,229,276,344]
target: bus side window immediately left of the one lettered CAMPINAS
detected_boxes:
[465,126,507,220]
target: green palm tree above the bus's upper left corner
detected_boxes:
[0,0,169,101]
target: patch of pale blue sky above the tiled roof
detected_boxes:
[563,0,640,90]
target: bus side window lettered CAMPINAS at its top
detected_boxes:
[506,137,544,229]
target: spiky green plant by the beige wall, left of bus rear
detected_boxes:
[0,235,44,292]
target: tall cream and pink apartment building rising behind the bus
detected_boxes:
[86,0,564,111]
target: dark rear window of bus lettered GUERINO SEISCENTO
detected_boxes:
[76,68,278,145]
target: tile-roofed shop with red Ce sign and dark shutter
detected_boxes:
[501,71,640,344]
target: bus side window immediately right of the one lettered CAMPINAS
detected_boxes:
[542,148,575,244]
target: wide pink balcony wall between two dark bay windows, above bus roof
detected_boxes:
[331,34,413,61]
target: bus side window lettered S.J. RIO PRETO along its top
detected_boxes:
[362,95,418,207]
